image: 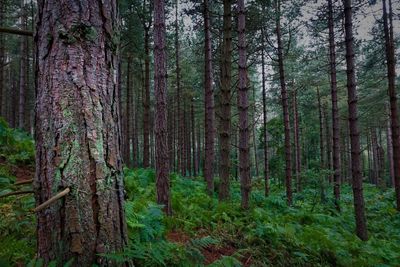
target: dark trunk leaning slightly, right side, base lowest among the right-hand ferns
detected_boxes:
[343,0,368,240]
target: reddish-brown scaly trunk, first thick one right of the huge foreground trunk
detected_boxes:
[154,0,172,215]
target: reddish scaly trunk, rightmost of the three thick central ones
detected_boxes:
[237,0,251,209]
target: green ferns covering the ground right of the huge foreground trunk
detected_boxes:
[125,169,400,266]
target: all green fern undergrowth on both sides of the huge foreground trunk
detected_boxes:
[0,121,400,266]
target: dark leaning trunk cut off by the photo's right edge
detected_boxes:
[382,0,400,211]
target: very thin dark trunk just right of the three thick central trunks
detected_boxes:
[261,28,269,196]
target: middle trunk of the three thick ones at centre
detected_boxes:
[219,0,232,200]
